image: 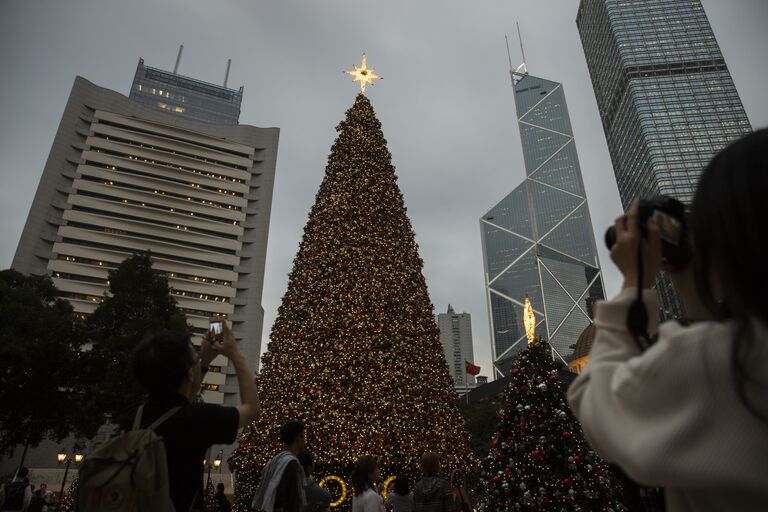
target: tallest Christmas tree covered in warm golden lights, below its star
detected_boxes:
[230,72,474,510]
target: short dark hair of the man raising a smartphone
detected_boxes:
[131,331,195,395]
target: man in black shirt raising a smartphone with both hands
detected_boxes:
[121,319,261,511]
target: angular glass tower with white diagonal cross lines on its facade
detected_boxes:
[480,72,605,376]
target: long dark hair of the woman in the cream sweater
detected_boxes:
[691,129,768,421]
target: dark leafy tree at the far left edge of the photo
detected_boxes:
[0,270,86,460]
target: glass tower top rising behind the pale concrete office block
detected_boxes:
[129,59,243,124]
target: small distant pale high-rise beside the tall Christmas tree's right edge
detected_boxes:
[437,304,475,392]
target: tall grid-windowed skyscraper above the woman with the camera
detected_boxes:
[576,0,751,317]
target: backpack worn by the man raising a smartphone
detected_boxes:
[76,405,181,512]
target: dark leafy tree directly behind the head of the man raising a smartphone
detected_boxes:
[83,253,189,422]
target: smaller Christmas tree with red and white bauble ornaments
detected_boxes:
[481,339,626,512]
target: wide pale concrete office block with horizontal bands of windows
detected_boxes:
[12,77,279,403]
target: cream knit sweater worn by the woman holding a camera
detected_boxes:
[568,289,768,512]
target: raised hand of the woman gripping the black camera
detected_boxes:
[611,200,661,289]
